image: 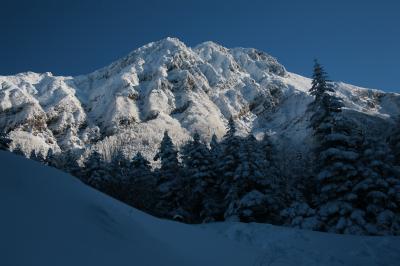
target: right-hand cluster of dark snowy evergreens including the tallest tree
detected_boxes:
[282,62,400,235]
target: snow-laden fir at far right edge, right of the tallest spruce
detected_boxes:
[353,139,400,235]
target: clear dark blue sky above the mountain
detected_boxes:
[0,0,400,92]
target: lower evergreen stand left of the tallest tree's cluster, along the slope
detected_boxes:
[47,122,284,223]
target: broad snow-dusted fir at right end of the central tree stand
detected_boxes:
[225,134,279,222]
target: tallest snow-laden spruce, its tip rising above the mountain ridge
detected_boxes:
[310,62,362,234]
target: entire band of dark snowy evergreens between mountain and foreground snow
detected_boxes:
[0,62,400,235]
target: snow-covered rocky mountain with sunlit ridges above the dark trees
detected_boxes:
[0,38,400,158]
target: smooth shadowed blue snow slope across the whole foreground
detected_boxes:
[0,151,400,266]
